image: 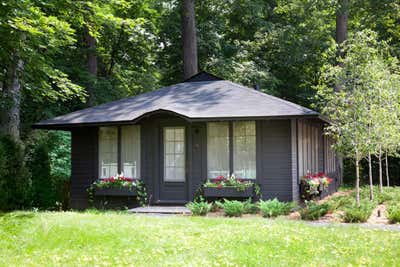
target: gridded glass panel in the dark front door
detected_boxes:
[164,127,185,182]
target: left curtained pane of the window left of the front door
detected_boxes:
[99,127,118,178]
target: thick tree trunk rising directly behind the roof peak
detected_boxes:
[182,0,198,79]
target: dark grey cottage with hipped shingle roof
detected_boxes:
[34,72,338,208]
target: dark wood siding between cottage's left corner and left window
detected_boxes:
[70,127,98,209]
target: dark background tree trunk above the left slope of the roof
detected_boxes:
[84,27,97,106]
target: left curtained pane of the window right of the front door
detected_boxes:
[207,122,229,178]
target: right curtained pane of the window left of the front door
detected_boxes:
[121,125,140,179]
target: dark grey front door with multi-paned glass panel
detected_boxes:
[159,126,188,203]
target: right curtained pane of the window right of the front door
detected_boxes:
[233,121,256,179]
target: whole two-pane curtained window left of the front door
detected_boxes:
[99,125,140,179]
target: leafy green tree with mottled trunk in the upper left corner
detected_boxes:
[0,0,82,140]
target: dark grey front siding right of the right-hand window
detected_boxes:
[257,120,293,201]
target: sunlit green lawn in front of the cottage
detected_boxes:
[0,212,400,266]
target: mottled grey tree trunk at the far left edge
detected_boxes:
[0,52,24,141]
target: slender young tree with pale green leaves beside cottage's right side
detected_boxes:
[318,31,400,204]
